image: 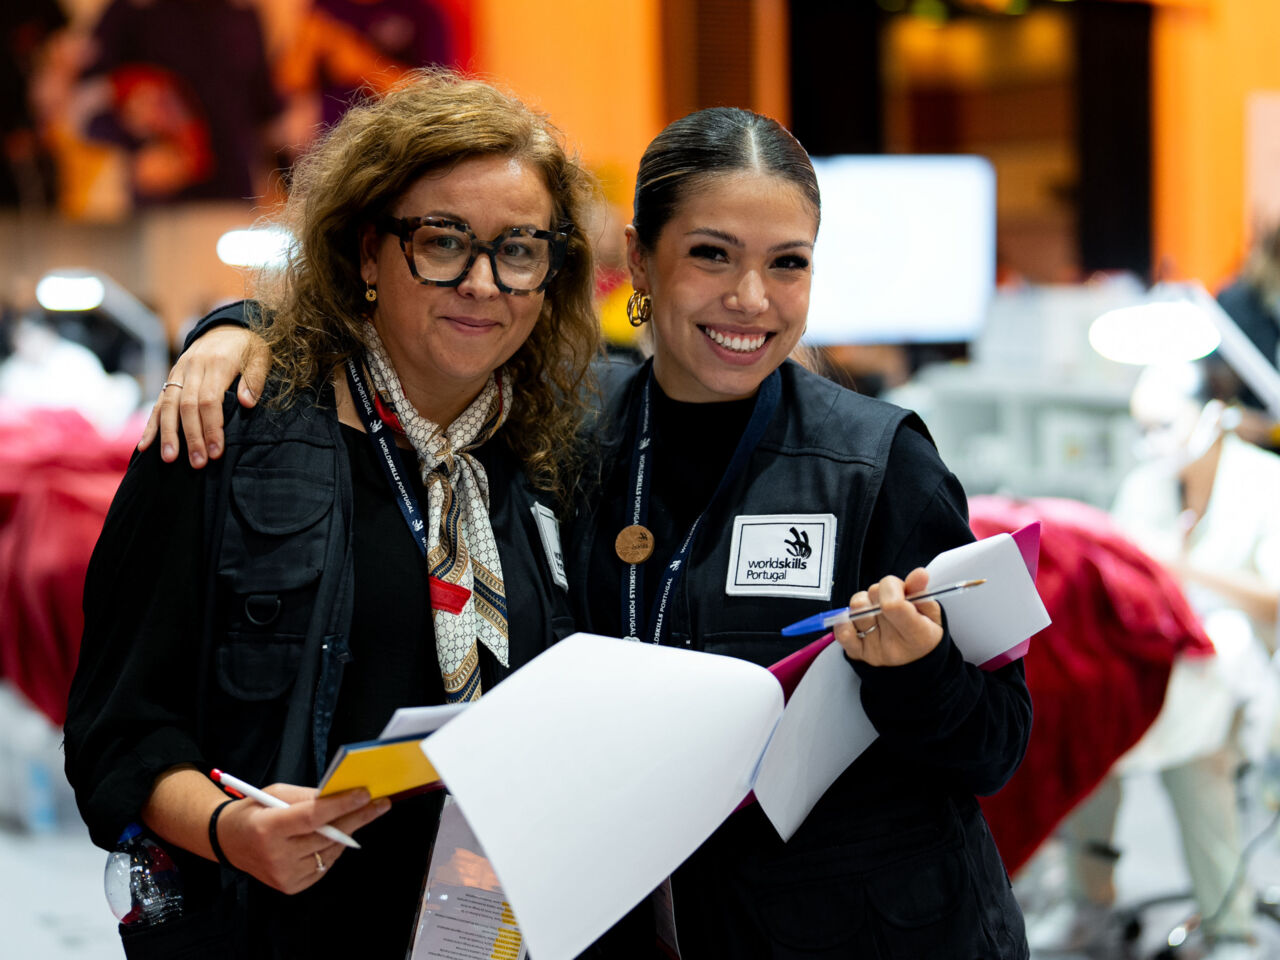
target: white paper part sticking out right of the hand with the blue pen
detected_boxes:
[925,534,1050,666]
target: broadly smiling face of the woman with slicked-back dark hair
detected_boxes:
[627,170,818,403]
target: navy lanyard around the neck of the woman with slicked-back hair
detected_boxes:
[621,365,782,644]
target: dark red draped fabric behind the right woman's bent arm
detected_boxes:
[969,497,1213,872]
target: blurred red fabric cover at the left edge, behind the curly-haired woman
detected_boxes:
[0,408,141,726]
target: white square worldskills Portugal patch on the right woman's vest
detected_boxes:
[724,513,836,600]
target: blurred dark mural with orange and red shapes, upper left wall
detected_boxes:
[22,0,472,221]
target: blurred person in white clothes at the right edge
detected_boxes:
[1030,364,1280,960]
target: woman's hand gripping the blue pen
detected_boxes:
[832,567,942,667]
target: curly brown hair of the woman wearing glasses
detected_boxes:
[259,69,600,507]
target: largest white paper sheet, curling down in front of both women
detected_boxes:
[422,634,782,960]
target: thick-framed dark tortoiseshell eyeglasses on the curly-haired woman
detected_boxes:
[376,216,568,294]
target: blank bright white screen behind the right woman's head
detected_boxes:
[805,156,996,344]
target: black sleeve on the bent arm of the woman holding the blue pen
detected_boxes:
[854,429,1032,794]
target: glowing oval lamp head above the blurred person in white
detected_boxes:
[1089,300,1222,365]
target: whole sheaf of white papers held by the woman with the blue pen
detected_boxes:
[422,534,1050,960]
